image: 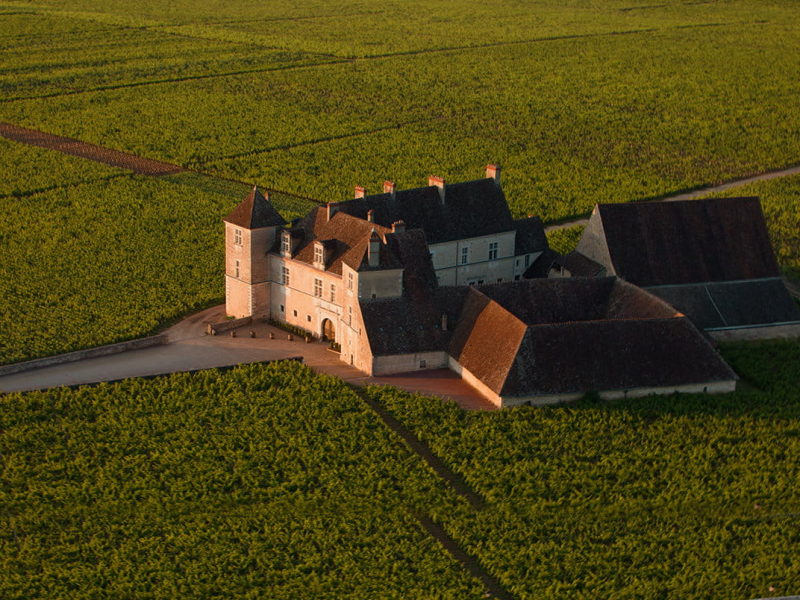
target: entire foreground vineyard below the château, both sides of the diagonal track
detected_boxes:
[0,341,800,599]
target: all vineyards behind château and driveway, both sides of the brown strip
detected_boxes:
[0,0,800,363]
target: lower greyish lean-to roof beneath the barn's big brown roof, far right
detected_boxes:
[648,278,800,330]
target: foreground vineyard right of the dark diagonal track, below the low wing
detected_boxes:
[370,341,800,598]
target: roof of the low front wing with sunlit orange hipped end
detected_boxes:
[449,278,736,396]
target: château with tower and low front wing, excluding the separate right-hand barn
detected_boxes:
[225,165,736,406]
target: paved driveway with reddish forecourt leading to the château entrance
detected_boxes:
[0,306,494,410]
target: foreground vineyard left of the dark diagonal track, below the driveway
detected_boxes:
[0,362,483,599]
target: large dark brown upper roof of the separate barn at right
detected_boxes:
[592,198,779,287]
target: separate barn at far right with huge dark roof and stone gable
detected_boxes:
[551,197,800,337]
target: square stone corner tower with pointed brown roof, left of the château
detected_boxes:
[224,187,286,318]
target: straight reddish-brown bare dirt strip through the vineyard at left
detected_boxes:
[0,123,184,175]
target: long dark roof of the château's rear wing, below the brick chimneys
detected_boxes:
[334,178,514,244]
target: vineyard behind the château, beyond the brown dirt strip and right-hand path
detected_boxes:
[0,0,800,220]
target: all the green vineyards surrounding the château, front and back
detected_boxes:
[0,0,800,598]
